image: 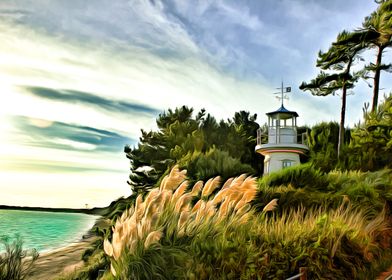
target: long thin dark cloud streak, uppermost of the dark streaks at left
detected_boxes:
[22,86,159,115]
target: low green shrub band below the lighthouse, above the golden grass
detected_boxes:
[255,165,392,216]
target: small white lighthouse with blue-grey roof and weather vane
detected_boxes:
[255,83,309,175]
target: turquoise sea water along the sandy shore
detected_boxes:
[0,209,97,252]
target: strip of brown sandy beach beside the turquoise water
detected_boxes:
[27,236,97,280]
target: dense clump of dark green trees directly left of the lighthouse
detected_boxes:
[125,106,262,193]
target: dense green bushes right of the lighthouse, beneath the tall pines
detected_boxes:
[309,94,392,172]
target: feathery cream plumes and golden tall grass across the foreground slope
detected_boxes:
[99,167,389,279]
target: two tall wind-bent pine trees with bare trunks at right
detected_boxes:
[300,0,392,162]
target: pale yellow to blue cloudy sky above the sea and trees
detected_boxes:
[0,0,392,208]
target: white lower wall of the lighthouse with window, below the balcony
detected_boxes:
[264,152,301,174]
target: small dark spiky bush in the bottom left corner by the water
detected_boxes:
[0,236,39,280]
